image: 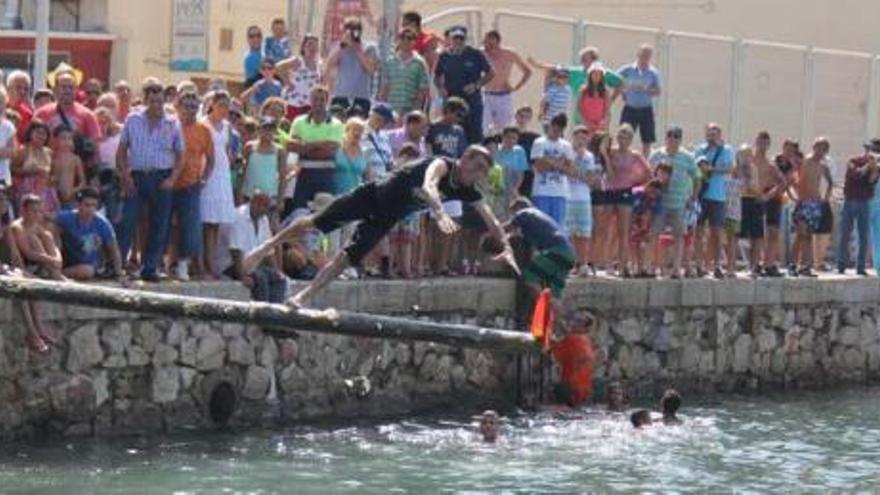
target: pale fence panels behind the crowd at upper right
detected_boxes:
[428,7,880,163]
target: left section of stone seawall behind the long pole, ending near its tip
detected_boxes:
[0,280,515,437]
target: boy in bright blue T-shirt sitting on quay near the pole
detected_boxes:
[55,187,123,281]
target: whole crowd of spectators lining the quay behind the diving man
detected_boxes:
[0,12,880,352]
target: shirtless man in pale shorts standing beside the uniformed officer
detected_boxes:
[483,31,532,131]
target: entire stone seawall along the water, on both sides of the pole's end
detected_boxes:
[0,278,880,436]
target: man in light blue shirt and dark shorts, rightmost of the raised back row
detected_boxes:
[614,45,660,156]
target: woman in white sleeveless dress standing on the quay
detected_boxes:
[200,91,235,279]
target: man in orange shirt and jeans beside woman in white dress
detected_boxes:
[171,91,214,281]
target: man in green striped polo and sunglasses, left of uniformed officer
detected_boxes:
[379,29,430,115]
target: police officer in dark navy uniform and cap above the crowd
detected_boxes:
[434,26,495,144]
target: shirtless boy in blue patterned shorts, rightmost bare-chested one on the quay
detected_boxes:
[794,138,834,277]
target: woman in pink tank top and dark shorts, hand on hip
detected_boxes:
[605,124,651,278]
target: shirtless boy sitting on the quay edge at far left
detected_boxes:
[9,194,67,280]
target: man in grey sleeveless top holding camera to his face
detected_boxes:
[324,17,379,118]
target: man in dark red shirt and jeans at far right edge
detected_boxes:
[837,139,880,276]
